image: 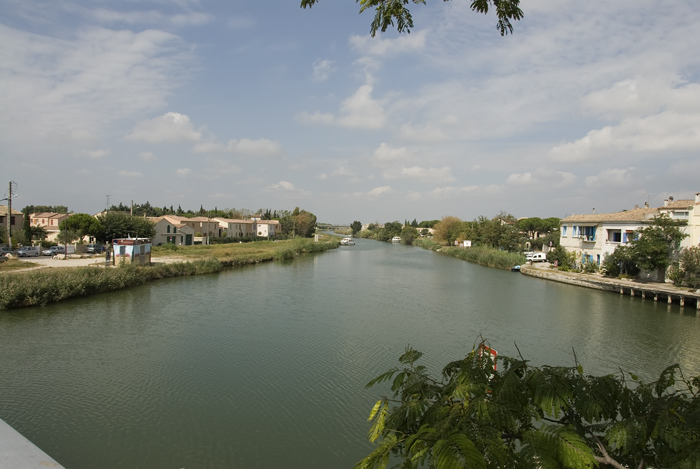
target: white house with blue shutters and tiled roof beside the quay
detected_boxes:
[559,204,659,265]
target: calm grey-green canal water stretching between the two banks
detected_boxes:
[0,240,700,469]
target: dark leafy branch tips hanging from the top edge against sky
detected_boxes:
[301,0,523,37]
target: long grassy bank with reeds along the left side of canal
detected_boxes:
[0,237,338,310]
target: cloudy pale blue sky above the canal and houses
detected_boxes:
[0,0,700,224]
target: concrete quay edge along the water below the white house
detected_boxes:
[520,263,700,310]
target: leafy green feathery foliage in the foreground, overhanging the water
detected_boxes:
[355,342,700,469]
